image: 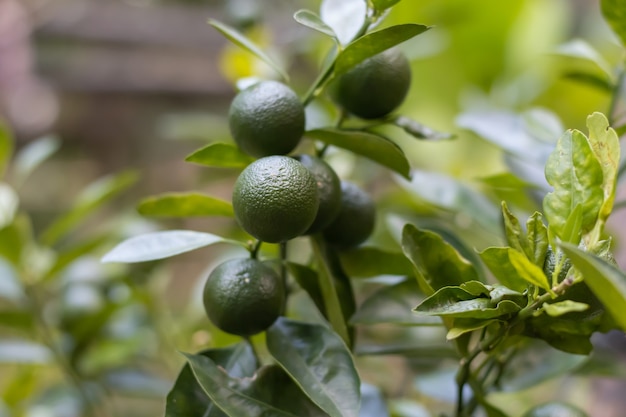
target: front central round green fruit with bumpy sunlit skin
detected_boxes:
[232,155,319,243]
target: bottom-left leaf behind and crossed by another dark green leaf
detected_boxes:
[165,343,257,417]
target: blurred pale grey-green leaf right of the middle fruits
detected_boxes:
[398,170,501,234]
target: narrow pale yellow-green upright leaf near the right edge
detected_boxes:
[587,110,626,232]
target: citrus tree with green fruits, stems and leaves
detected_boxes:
[94,0,626,417]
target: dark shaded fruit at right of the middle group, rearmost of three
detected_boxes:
[323,181,376,248]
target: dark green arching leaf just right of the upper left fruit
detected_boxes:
[305,129,411,178]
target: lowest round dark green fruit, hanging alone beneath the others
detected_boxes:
[203,258,285,336]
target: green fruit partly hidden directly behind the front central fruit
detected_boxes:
[295,155,341,234]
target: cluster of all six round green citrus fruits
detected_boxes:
[204,50,411,337]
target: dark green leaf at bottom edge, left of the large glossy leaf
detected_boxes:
[185,354,298,417]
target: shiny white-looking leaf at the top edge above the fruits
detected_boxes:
[320,0,367,45]
